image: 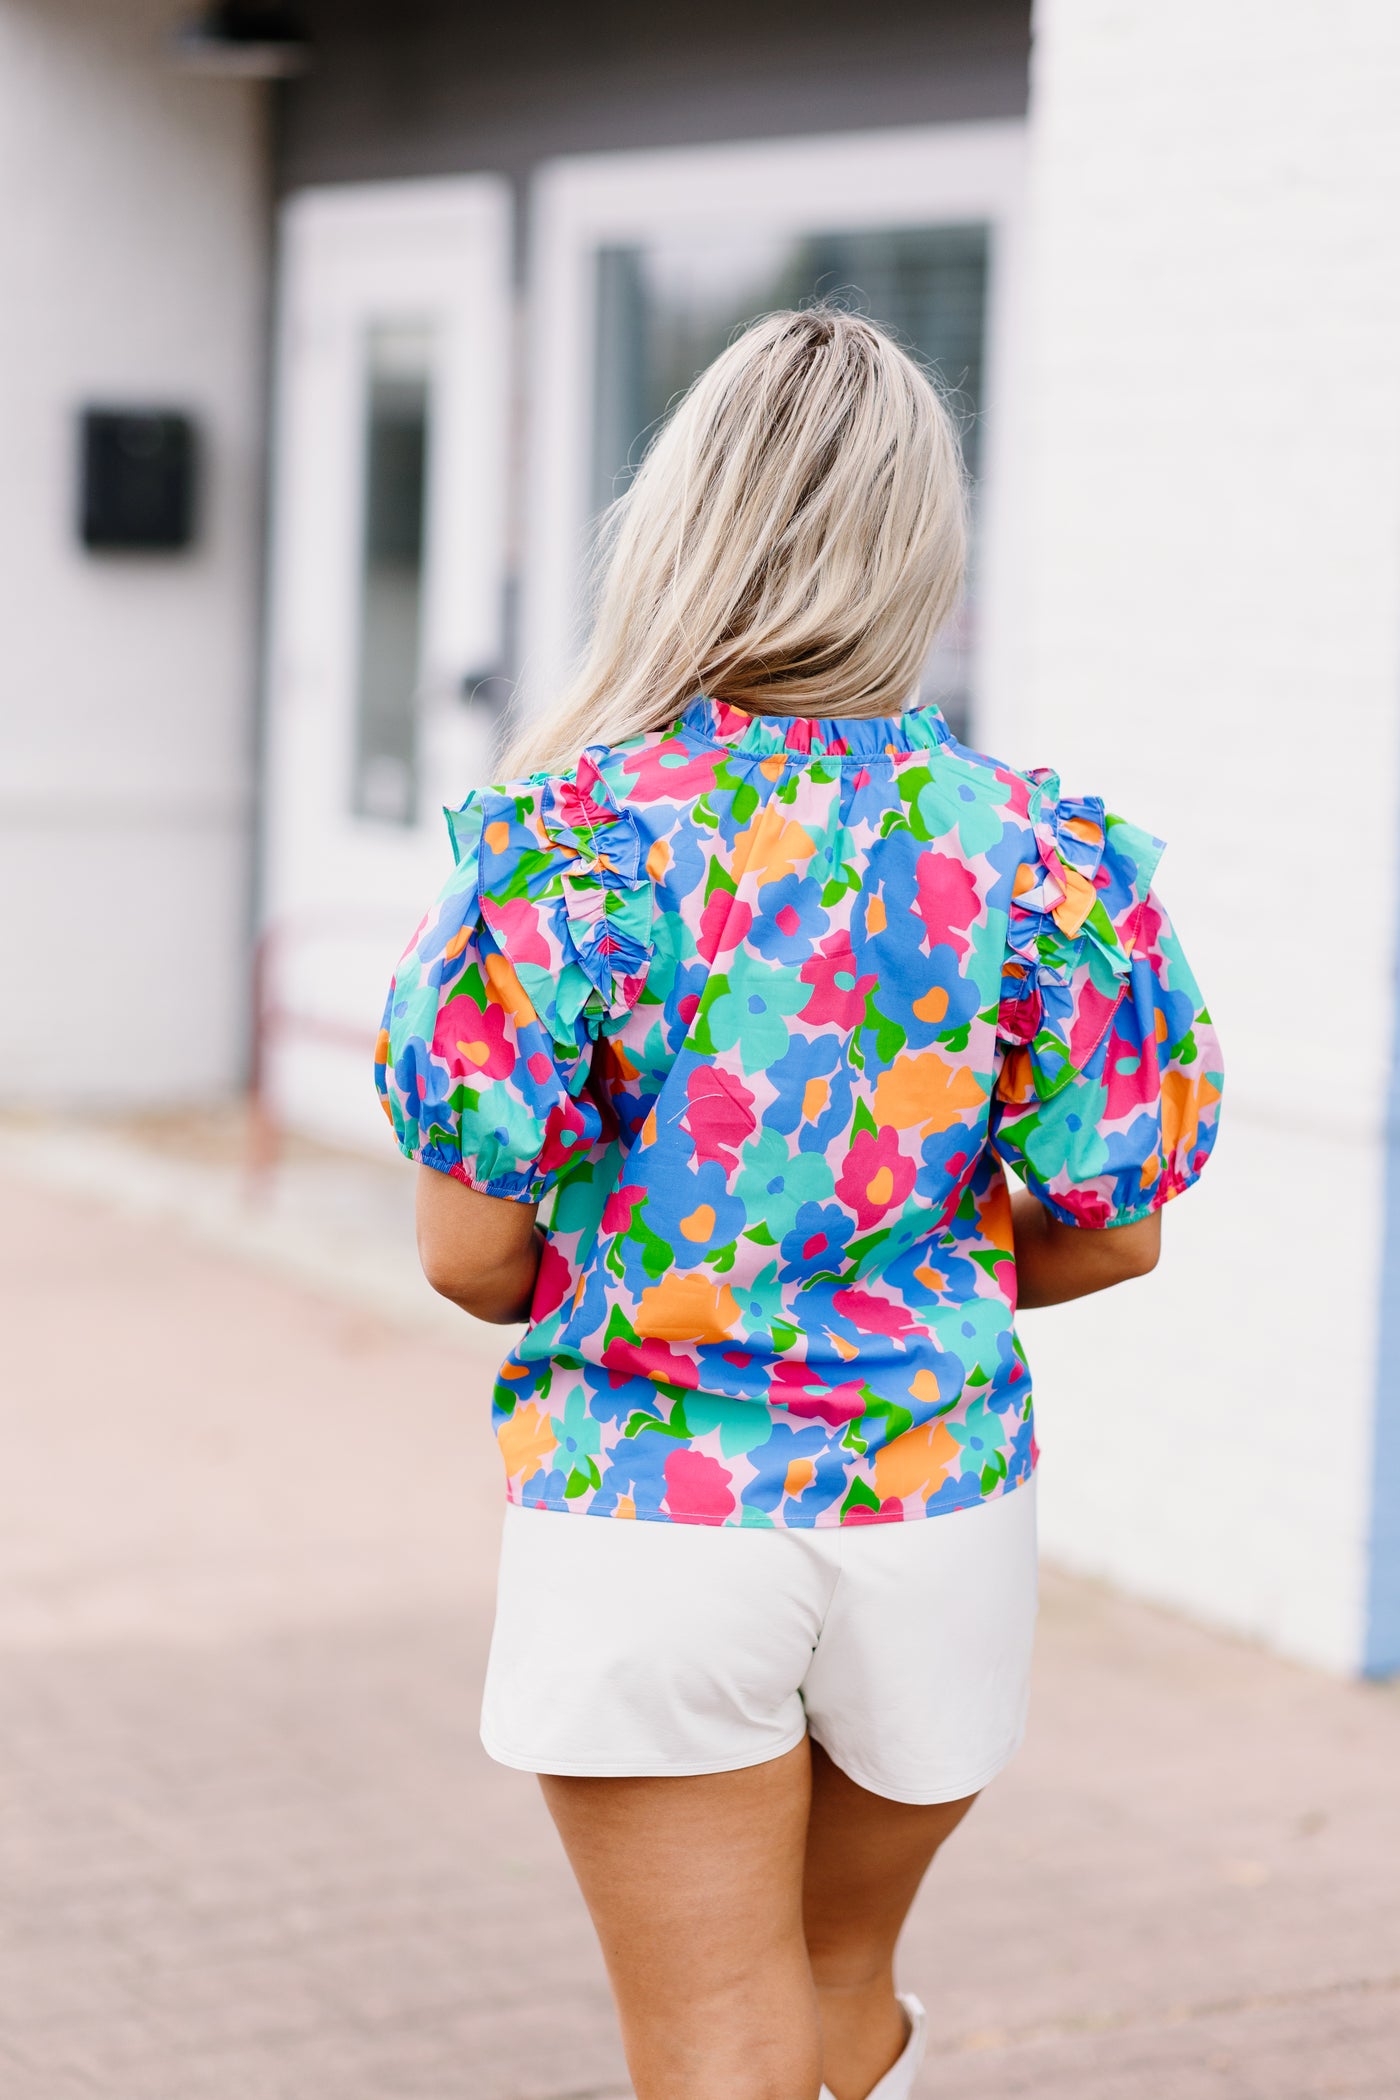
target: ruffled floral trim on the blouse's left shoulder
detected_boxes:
[445,746,655,1050]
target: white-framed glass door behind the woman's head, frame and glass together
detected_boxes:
[529,124,1022,755]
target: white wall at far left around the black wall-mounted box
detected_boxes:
[0,0,264,1105]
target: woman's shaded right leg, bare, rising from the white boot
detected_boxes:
[804,1743,976,2100]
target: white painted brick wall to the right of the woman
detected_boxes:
[1014,0,1400,1667]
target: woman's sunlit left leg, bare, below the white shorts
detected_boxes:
[539,1741,822,2100]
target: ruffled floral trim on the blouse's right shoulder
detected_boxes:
[997,769,1165,1100]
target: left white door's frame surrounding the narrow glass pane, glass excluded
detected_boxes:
[262,176,512,1145]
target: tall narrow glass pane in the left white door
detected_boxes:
[355,323,432,823]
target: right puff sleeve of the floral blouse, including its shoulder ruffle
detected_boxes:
[991,773,1222,1226]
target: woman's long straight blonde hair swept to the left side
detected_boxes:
[506,307,968,775]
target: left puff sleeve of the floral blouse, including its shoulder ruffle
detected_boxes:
[376,754,651,1203]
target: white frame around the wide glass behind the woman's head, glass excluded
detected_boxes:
[523,120,1026,743]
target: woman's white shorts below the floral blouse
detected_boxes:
[481,1481,1037,1802]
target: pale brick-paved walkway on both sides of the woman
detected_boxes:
[0,1163,1400,2100]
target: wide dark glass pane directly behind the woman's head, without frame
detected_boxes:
[594,225,987,731]
